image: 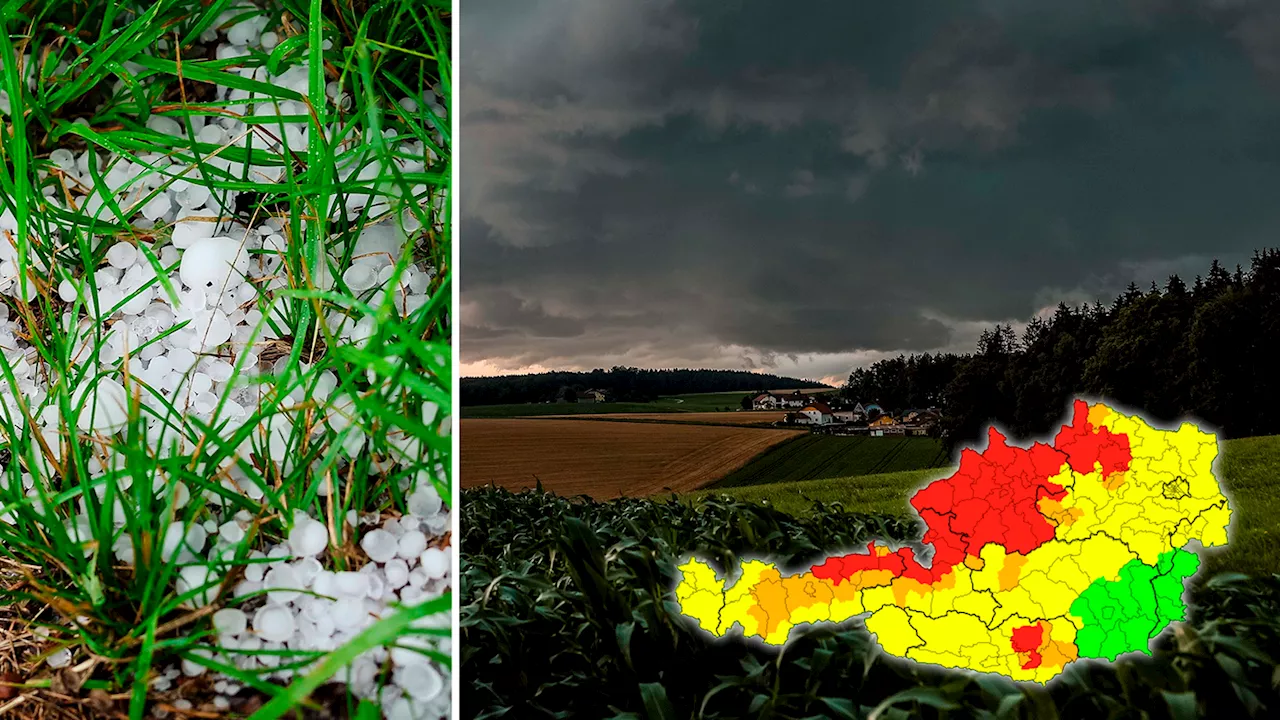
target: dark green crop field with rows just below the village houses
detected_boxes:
[716,434,951,487]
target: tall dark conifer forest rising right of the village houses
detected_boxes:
[841,250,1280,445]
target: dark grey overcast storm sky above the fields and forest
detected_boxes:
[458,0,1280,380]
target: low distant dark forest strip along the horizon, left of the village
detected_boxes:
[461,368,827,405]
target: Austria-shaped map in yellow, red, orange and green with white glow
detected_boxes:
[676,401,1231,683]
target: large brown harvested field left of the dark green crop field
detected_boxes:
[461,419,804,498]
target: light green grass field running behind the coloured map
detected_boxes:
[687,436,1280,575]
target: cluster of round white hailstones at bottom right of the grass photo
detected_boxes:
[166,486,452,720]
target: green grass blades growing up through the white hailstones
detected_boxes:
[0,0,452,719]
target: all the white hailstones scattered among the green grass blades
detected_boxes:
[0,8,451,720]
